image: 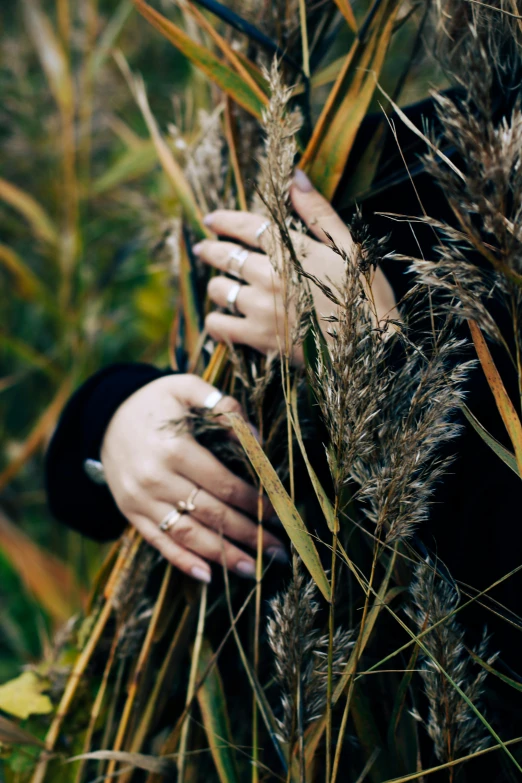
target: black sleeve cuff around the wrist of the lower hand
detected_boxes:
[45,364,170,541]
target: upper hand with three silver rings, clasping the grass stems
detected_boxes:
[193,169,398,361]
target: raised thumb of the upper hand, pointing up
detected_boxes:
[290,169,353,253]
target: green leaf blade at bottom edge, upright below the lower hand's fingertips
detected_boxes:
[197,640,239,783]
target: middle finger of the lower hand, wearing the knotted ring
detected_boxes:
[154,474,287,562]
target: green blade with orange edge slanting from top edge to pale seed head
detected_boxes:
[134,0,264,119]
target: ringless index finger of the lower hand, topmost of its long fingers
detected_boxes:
[170,437,273,519]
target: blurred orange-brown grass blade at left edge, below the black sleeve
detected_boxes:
[0,512,83,625]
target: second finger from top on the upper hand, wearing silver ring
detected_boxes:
[192,239,280,291]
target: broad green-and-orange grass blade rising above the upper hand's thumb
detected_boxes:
[299,0,399,199]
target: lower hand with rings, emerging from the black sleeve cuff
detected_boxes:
[101,375,287,582]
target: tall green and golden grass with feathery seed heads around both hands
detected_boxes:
[0,0,522,783]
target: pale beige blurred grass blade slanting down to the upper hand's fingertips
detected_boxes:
[115,52,206,238]
